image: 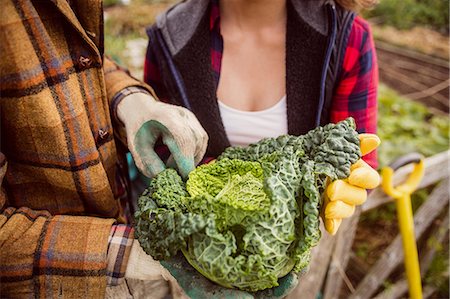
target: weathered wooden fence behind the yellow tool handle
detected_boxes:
[288,151,450,299]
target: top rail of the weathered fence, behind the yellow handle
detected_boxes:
[362,151,450,212]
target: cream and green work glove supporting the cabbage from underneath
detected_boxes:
[125,240,298,299]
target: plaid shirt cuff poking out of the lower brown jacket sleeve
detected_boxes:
[106,224,134,286]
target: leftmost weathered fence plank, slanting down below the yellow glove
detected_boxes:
[286,223,336,299]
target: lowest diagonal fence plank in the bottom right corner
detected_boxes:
[374,214,449,299]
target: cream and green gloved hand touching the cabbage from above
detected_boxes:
[117,93,208,178]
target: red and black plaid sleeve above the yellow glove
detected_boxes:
[331,16,378,169]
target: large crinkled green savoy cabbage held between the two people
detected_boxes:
[136,119,361,291]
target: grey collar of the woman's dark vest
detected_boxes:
[156,0,333,55]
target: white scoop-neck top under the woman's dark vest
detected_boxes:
[218,96,287,146]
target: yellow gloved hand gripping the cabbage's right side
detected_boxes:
[322,134,380,235]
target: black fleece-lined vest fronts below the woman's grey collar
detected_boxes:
[147,1,355,157]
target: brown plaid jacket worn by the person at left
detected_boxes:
[0,0,152,298]
